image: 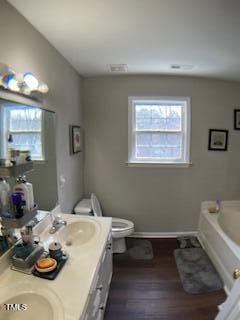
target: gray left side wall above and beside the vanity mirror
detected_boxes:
[0,0,83,210]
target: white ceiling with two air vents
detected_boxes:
[9,0,240,80]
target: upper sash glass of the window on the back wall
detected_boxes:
[135,104,182,130]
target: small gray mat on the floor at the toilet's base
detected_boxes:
[117,238,153,260]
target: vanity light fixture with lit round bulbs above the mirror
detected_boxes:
[0,63,48,96]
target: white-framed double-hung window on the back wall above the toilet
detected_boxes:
[128,97,190,165]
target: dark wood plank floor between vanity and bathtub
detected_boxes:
[104,239,226,320]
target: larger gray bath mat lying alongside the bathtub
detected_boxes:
[174,248,223,293]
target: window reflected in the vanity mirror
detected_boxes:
[4,105,44,160]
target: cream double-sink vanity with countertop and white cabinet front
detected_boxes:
[0,210,112,320]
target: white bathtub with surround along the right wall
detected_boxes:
[198,201,240,294]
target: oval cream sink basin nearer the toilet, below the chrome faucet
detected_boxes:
[57,220,99,246]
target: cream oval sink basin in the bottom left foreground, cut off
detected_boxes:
[0,283,64,320]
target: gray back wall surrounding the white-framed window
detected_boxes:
[83,76,240,232]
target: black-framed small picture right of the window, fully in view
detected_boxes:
[208,129,228,151]
